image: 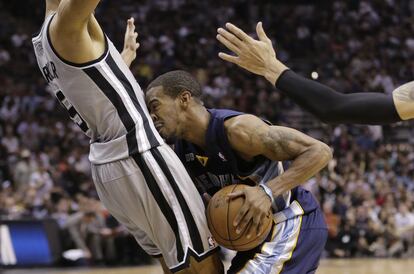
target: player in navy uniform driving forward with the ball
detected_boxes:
[146,71,332,274]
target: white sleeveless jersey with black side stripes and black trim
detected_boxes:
[32,14,163,164]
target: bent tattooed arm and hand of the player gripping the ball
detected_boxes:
[225,115,332,236]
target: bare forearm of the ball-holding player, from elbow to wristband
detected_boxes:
[268,142,332,197]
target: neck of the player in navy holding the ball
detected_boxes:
[181,105,210,149]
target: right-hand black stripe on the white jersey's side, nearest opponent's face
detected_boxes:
[106,54,160,151]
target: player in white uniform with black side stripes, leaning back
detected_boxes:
[33,0,223,273]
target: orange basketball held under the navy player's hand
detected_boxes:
[207,184,273,251]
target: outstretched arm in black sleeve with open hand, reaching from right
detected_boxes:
[217,22,406,124]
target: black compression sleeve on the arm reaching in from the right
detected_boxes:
[276,71,401,124]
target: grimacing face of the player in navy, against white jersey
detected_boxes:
[146,87,179,139]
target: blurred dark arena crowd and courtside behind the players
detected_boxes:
[0,0,414,274]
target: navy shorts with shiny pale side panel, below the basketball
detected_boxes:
[228,209,327,274]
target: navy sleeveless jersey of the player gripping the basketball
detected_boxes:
[175,109,319,218]
